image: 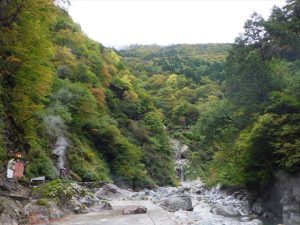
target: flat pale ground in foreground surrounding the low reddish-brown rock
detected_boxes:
[44,201,176,225]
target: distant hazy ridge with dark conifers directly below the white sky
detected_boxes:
[119,44,231,82]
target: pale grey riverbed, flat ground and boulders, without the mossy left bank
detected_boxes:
[42,181,278,225]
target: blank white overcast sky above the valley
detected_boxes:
[69,0,285,47]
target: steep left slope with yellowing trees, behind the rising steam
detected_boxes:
[0,0,176,188]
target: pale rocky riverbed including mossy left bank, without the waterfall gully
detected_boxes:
[0,178,297,225]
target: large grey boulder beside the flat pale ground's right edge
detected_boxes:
[161,193,193,212]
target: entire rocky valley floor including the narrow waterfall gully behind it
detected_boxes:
[0,139,300,225]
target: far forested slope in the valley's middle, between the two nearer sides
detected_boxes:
[119,44,231,181]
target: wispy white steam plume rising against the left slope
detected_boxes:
[44,115,69,170]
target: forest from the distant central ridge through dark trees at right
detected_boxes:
[120,0,300,188]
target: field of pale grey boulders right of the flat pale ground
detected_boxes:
[143,181,262,225]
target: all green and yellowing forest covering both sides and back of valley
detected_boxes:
[0,0,300,192]
